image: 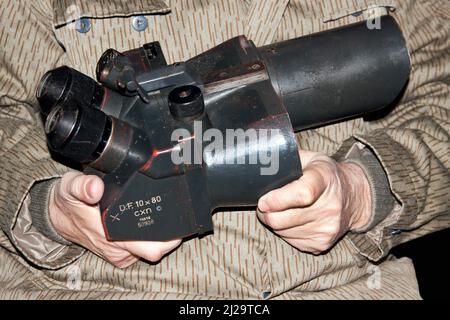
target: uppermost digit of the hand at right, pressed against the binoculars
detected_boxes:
[258,167,326,212]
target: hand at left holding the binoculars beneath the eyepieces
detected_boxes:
[49,172,181,268]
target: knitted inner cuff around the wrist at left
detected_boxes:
[29,179,72,245]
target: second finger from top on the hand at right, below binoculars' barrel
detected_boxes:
[257,208,320,231]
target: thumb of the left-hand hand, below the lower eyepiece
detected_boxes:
[61,172,104,205]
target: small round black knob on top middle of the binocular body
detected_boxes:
[169,85,205,119]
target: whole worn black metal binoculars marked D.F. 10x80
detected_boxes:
[37,16,410,241]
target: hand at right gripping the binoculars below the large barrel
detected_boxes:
[258,151,372,254]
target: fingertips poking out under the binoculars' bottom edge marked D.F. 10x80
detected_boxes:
[124,239,181,262]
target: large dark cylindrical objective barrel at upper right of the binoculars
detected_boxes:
[259,16,411,130]
